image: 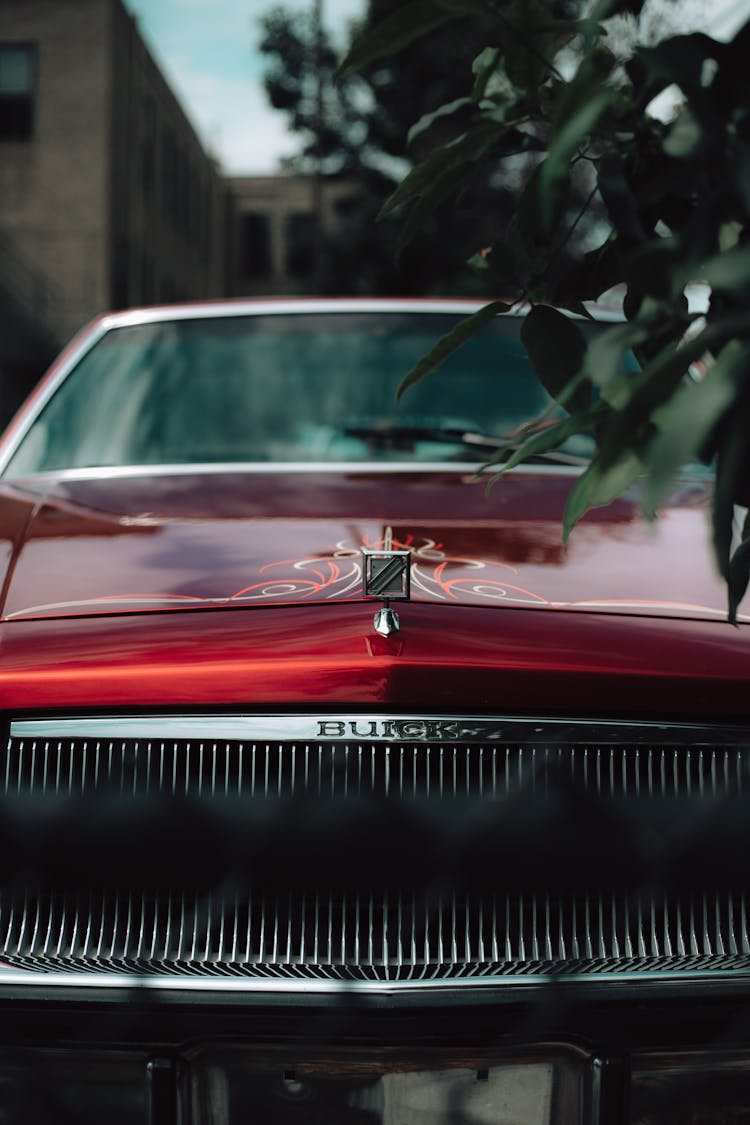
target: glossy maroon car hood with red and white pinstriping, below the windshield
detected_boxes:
[0,468,725,621]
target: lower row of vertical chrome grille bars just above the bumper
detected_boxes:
[0,892,750,981]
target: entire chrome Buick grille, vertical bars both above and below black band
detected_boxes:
[0,717,750,981]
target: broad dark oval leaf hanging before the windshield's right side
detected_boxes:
[521,305,591,413]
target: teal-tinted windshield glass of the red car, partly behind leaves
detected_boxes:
[4,312,629,476]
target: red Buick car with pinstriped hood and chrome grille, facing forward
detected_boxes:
[0,300,750,1125]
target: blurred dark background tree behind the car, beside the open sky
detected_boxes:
[261,0,530,296]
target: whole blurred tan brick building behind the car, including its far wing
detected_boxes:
[0,0,351,428]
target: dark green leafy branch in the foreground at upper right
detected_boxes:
[342,0,750,621]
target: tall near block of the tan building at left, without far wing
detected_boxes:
[0,0,226,346]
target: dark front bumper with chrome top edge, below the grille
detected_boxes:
[0,972,750,1125]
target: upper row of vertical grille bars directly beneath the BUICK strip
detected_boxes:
[4,738,750,800]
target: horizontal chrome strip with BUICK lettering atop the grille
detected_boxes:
[10,711,750,746]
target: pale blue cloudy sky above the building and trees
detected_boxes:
[125,0,750,174]
